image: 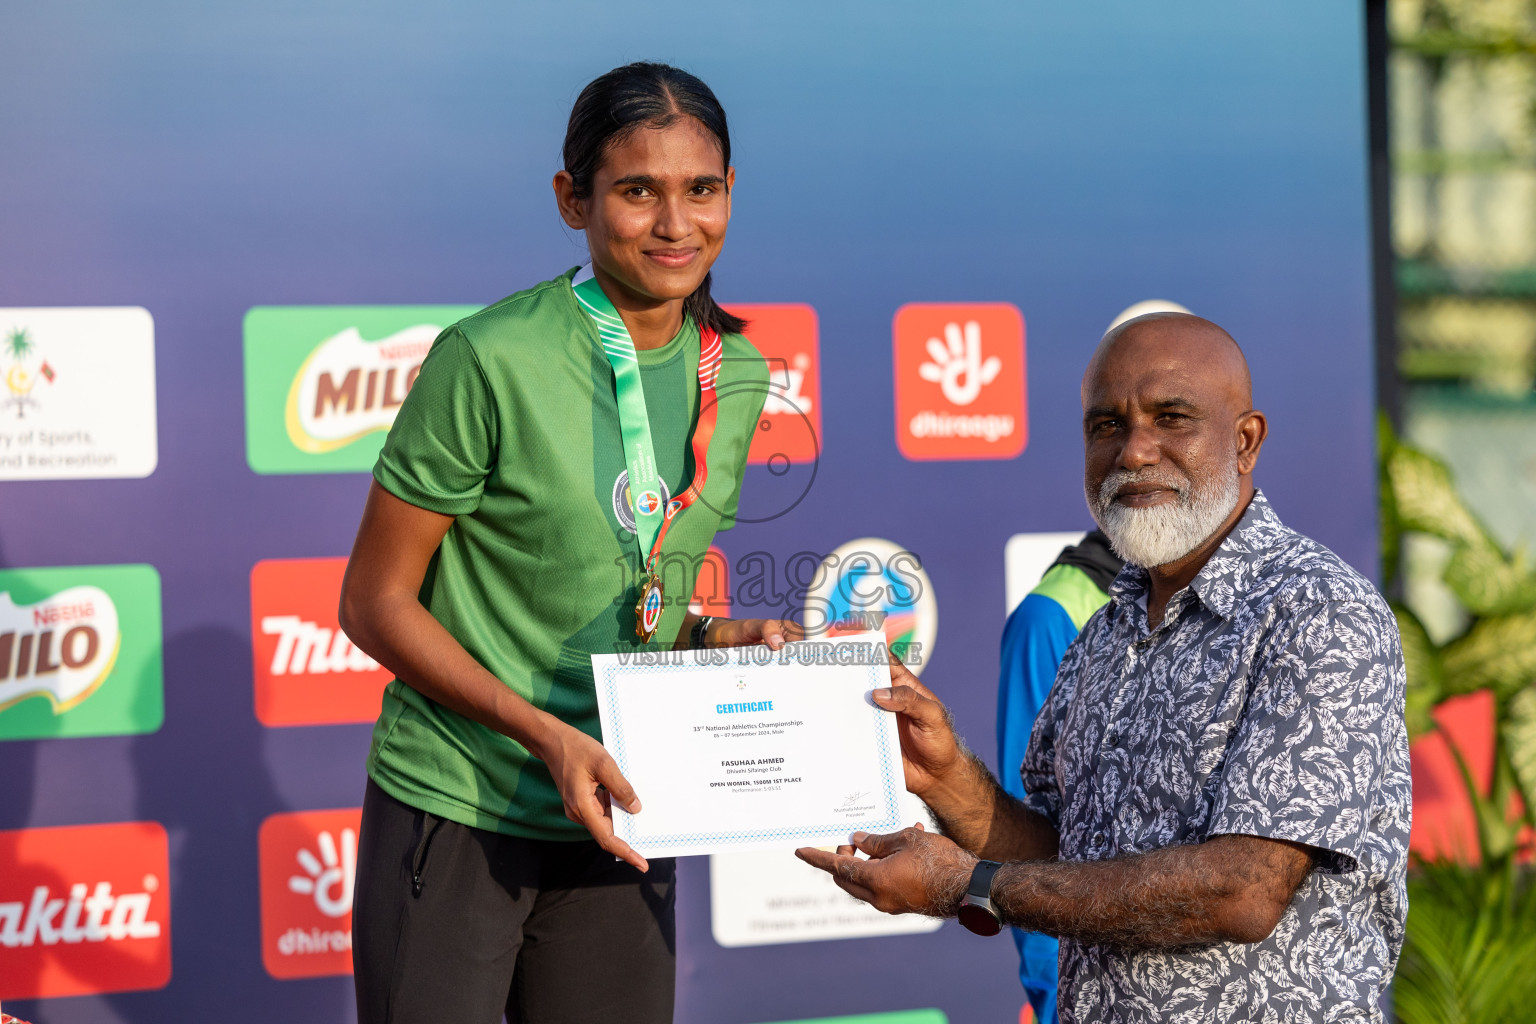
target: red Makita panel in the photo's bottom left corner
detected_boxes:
[0,821,170,999]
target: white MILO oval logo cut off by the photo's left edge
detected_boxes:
[0,586,118,714]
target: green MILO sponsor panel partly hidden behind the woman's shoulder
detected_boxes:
[244,306,479,473]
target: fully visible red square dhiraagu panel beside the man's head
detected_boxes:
[892,302,1029,459]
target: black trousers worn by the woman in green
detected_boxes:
[352,780,677,1024]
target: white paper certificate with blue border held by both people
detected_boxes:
[591,633,905,857]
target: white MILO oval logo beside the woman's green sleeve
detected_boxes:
[284,324,441,453]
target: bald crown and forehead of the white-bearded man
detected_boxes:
[1083,312,1253,411]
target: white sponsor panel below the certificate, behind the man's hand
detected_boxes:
[710,794,943,947]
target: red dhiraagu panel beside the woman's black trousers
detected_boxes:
[257,808,362,978]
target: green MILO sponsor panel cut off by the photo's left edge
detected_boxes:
[0,565,166,740]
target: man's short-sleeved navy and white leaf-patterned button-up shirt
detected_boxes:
[1021,494,1412,1024]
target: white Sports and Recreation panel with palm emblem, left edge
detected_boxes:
[0,306,160,481]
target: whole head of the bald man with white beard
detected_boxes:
[1083,312,1269,568]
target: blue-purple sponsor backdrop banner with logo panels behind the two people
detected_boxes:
[0,0,1376,1024]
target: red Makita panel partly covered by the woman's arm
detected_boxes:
[250,559,393,725]
